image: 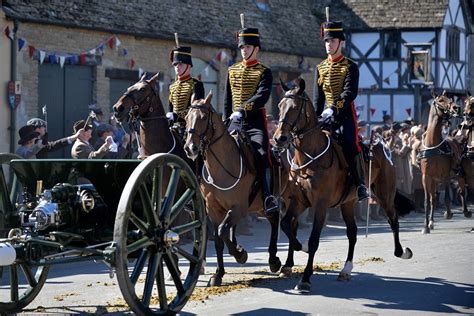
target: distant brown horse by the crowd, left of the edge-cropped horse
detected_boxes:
[419,92,472,234]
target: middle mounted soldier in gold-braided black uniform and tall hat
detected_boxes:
[224,28,278,216]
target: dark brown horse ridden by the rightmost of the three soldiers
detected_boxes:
[273,79,413,293]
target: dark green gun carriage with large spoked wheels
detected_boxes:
[0,154,207,315]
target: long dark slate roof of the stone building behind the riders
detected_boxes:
[2,0,325,57]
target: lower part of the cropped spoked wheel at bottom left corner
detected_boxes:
[0,263,49,314]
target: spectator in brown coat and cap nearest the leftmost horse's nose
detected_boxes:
[71,120,113,159]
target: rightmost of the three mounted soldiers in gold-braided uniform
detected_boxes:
[316,21,368,201]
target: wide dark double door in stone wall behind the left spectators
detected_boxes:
[38,64,93,158]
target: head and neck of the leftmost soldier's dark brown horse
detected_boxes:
[113,73,186,160]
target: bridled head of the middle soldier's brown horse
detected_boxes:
[184,91,217,160]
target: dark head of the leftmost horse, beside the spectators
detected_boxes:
[113,73,160,122]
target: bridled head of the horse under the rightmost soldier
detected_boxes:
[273,79,311,148]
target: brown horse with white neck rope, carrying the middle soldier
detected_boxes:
[184,93,289,286]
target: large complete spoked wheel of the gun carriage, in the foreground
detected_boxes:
[114,154,207,315]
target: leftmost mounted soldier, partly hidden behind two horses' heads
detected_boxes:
[166,33,204,132]
